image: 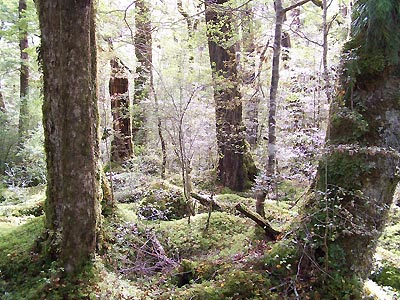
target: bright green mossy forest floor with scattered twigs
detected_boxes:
[0,173,400,300]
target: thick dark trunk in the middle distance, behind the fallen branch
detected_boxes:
[206,0,246,191]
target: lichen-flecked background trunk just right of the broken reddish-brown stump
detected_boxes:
[132,0,152,145]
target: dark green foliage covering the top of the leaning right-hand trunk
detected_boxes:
[344,0,400,81]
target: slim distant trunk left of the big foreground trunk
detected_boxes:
[18,0,29,143]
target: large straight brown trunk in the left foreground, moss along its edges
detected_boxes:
[36,0,101,273]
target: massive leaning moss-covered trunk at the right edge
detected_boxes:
[290,0,400,299]
